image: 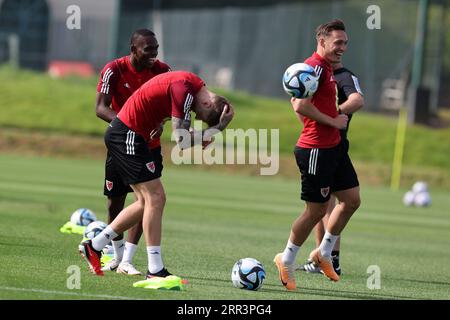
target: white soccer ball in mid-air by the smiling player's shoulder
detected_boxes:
[283,63,319,99]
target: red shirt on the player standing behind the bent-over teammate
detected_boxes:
[97,56,170,149]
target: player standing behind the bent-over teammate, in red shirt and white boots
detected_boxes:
[96,29,170,275]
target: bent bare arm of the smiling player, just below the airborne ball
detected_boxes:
[292,98,348,129]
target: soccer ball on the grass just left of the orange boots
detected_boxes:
[231,258,266,290]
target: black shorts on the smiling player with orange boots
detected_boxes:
[294,143,359,203]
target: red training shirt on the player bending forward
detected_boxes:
[117,71,205,141]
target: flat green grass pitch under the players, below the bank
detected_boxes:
[0,155,450,300]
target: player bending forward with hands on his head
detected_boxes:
[79,71,234,278]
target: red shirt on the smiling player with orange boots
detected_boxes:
[297,52,341,148]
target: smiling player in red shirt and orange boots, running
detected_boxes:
[274,20,359,290]
